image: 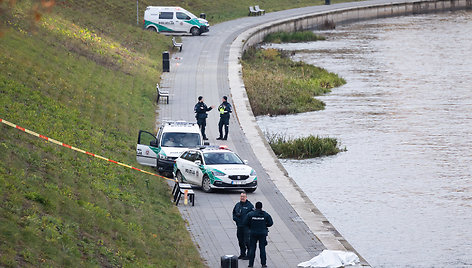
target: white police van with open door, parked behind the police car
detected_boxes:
[136,121,208,172]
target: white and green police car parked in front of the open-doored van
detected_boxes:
[174,146,257,192]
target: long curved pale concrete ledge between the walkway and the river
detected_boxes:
[228,0,472,265]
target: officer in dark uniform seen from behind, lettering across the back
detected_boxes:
[244,202,274,267]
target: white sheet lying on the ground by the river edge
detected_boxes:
[298,249,359,268]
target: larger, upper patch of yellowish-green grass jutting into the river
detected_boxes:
[242,48,346,116]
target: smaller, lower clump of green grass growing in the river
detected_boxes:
[266,134,346,159]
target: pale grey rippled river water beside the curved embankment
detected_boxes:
[257,11,472,267]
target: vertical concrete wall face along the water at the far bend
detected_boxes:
[243,0,472,50]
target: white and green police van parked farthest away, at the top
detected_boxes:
[144,6,210,35]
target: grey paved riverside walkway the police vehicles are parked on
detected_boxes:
[157,1,402,267]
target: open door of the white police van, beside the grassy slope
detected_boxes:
[136,130,160,167]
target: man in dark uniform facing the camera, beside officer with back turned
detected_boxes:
[233,192,254,260]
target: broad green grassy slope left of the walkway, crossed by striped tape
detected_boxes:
[0,0,203,267]
